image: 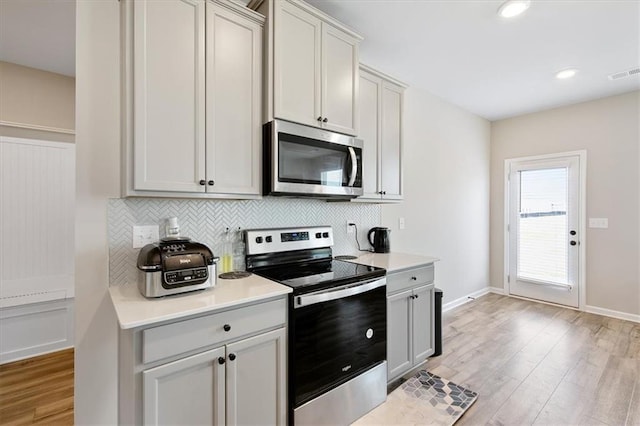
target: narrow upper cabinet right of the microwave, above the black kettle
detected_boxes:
[353,65,406,202]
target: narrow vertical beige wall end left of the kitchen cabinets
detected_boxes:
[74,1,120,425]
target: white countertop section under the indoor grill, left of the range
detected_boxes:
[109,274,292,329]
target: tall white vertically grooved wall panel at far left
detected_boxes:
[0,137,75,308]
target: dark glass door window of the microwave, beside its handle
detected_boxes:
[278,133,362,187]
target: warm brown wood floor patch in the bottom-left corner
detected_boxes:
[0,349,73,425]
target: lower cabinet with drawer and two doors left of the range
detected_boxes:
[119,299,287,425]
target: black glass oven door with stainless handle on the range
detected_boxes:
[289,278,387,409]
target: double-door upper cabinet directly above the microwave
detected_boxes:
[258,0,362,135]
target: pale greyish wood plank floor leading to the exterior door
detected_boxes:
[426,294,640,426]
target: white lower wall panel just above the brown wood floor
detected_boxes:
[0,299,75,364]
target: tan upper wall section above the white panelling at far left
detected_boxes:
[0,61,76,142]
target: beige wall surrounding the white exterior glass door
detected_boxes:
[491,91,640,315]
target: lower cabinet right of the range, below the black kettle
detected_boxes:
[387,265,435,381]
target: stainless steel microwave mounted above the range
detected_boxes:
[263,120,363,199]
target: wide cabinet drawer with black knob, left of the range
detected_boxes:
[142,299,287,364]
